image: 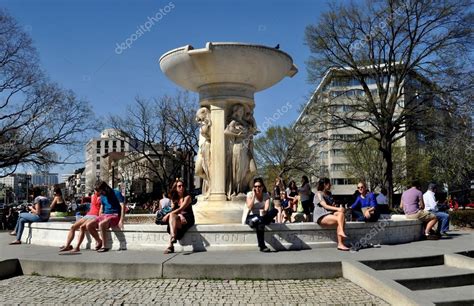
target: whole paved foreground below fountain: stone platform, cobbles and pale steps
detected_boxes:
[0,232,474,305]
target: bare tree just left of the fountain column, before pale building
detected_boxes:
[110,92,199,189]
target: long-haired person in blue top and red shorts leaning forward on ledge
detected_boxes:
[86,181,125,253]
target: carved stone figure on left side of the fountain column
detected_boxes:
[195,107,211,199]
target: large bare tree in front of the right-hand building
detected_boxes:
[302,0,474,203]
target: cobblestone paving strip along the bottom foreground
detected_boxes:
[0,276,389,305]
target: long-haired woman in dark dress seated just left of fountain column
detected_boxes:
[163,179,194,254]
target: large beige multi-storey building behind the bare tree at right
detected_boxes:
[295,69,444,195]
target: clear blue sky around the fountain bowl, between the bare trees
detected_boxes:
[0,0,327,178]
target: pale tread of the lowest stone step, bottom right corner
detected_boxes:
[416,285,474,305]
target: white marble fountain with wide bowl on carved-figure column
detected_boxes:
[160,43,298,224]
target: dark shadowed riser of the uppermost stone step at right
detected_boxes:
[361,255,444,271]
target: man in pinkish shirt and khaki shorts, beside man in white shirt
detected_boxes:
[400,181,439,240]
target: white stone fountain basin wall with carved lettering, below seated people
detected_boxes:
[23,220,422,251]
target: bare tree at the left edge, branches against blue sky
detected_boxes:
[0,10,93,177]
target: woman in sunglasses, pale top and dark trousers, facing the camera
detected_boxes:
[245,177,278,252]
